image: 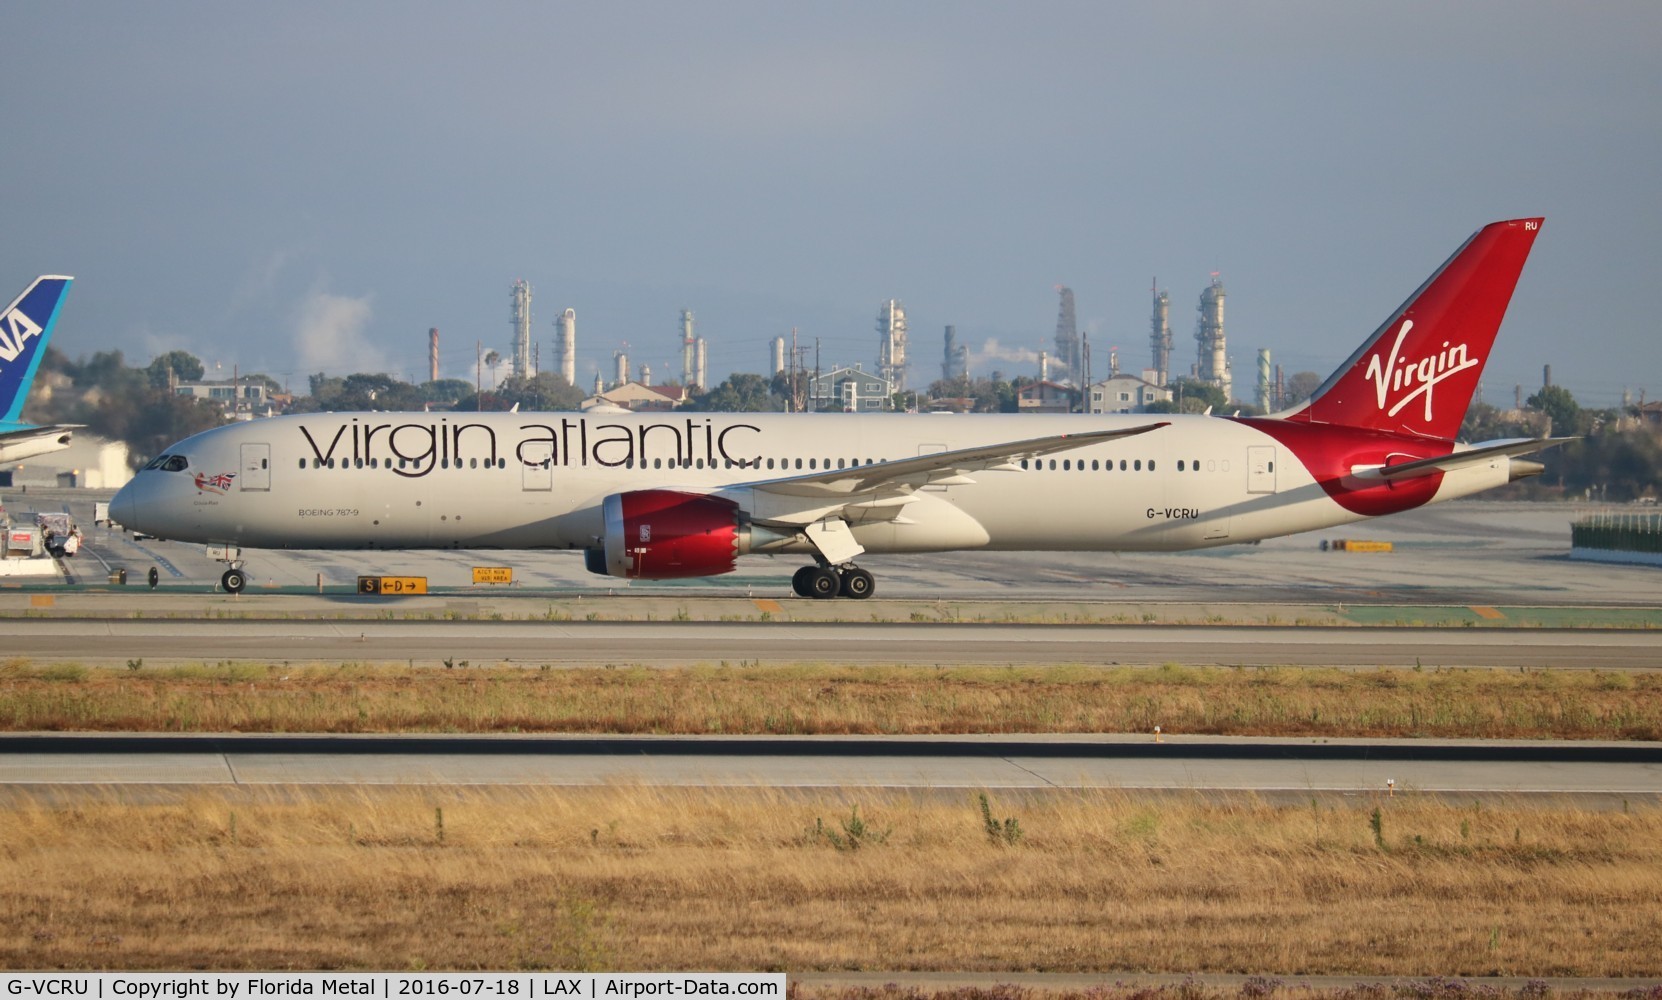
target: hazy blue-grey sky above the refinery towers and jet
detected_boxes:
[0,0,1662,405]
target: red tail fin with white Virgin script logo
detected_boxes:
[1286,219,1541,440]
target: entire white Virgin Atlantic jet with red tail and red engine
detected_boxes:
[110,219,1554,598]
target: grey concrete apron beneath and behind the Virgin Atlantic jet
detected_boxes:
[7,488,1662,608]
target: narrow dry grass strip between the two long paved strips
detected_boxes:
[0,661,1662,739]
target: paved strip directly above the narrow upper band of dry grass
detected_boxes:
[7,618,1662,669]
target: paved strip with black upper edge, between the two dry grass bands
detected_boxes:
[0,724,1662,801]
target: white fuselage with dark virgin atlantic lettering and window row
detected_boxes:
[111,414,1509,553]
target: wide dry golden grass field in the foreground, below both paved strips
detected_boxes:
[0,787,1662,977]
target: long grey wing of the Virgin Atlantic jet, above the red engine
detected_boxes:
[745,420,1168,527]
